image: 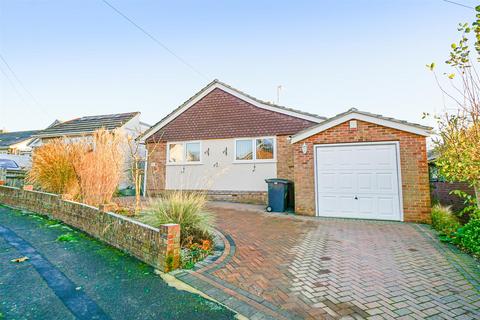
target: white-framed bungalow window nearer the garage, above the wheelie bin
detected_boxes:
[235,138,275,161]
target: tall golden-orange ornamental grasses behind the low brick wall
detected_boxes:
[28,129,124,206]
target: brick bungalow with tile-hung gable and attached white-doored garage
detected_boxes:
[139,80,431,221]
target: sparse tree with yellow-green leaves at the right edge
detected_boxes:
[427,6,480,206]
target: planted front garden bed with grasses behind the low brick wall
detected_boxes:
[23,130,214,269]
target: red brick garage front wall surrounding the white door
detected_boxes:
[294,120,430,222]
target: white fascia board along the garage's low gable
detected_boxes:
[291,112,430,144]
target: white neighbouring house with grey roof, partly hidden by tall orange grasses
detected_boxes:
[31,112,150,188]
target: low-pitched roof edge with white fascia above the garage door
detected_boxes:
[291,108,432,143]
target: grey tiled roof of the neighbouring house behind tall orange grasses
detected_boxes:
[34,112,140,138]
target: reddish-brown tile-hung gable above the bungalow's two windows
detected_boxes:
[148,88,315,142]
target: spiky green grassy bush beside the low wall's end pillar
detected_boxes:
[139,191,214,247]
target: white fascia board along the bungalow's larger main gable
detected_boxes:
[140,83,324,142]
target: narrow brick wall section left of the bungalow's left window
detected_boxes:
[147,142,167,196]
